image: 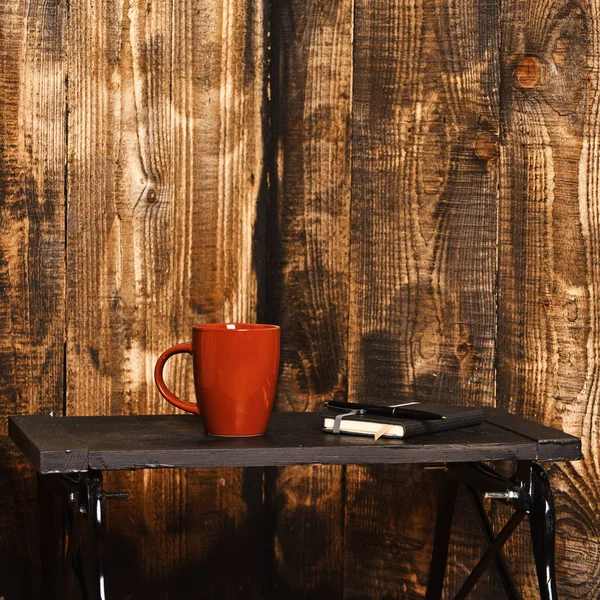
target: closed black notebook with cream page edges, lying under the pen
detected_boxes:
[323,403,484,439]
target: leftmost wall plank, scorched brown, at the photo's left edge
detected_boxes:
[0,0,66,600]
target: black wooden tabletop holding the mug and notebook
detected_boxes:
[9,408,581,473]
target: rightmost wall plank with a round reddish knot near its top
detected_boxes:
[498,0,600,598]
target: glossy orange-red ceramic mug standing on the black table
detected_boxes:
[154,323,279,436]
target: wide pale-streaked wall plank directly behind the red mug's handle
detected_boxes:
[67,0,266,598]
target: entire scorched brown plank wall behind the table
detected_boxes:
[0,0,600,600]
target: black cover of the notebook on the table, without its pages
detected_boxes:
[323,403,484,439]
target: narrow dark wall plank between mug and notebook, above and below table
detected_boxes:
[265,0,353,599]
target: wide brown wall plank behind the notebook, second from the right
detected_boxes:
[345,0,499,598]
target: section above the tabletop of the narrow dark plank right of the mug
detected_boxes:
[268,0,352,410]
